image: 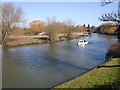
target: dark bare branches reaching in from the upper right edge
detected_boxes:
[99,0,120,41]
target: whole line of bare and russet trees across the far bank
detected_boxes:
[0,3,117,45]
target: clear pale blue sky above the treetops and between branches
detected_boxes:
[11,2,118,26]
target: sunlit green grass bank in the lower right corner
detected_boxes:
[53,58,120,90]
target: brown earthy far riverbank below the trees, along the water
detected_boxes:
[3,35,88,47]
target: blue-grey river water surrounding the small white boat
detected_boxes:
[2,34,117,88]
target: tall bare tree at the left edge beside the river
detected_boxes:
[1,3,23,45]
